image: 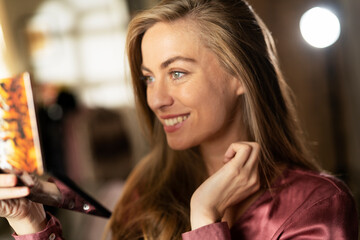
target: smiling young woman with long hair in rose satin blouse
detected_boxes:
[0,0,358,240]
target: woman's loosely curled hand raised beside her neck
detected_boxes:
[190,142,260,229]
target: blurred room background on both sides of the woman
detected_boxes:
[0,0,360,240]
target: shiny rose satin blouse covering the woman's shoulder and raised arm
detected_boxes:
[183,169,358,240]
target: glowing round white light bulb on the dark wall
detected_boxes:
[300,7,340,48]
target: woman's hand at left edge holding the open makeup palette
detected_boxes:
[0,174,46,235]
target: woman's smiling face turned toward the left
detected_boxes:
[141,20,243,150]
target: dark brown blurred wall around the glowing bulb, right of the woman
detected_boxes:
[249,0,360,206]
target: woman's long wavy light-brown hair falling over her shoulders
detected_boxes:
[110,0,319,240]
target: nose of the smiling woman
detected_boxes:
[147,79,174,111]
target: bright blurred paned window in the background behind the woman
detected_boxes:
[26,0,133,107]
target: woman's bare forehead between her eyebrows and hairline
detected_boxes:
[141,20,205,64]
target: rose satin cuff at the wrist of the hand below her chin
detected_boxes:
[182,222,231,240]
